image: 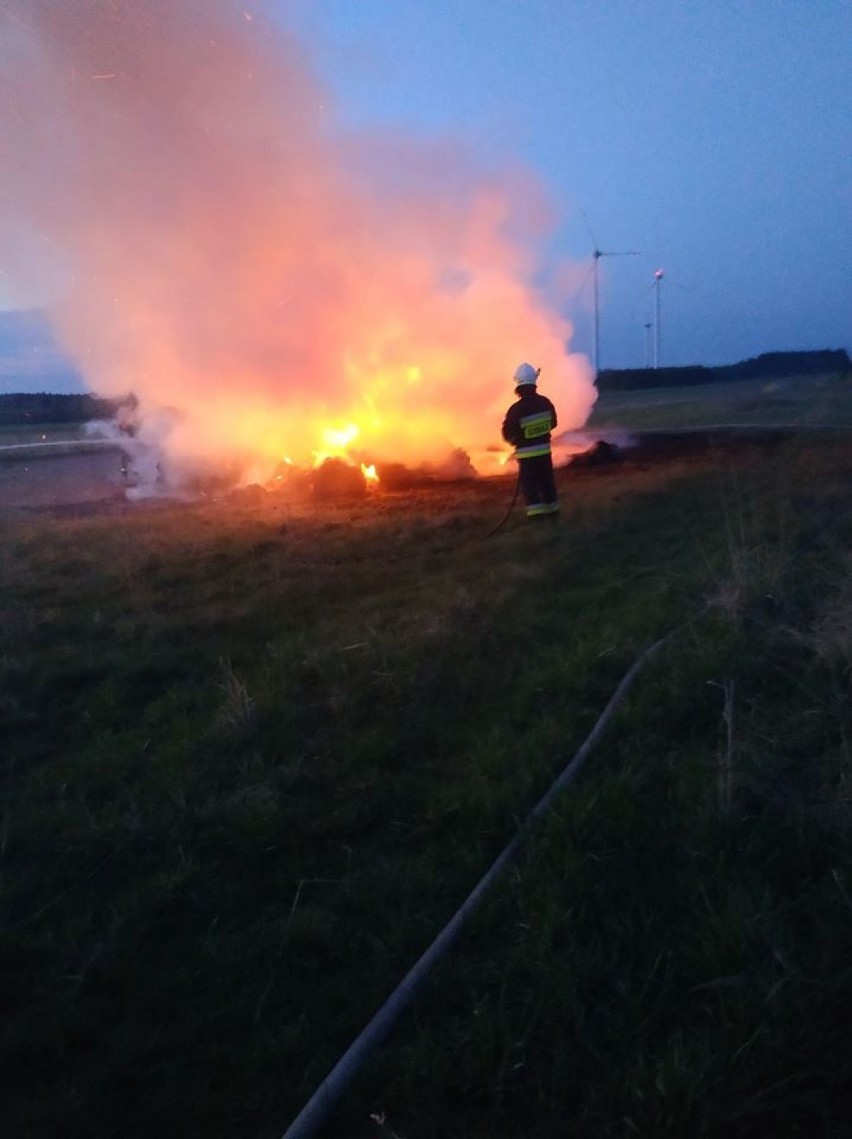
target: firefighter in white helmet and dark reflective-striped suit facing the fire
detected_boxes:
[502,363,559,519]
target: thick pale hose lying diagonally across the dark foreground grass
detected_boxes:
[282,628,682,1139]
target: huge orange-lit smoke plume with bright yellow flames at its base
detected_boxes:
[0,0,595,477]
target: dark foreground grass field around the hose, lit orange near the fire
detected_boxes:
[0,423,852,1139]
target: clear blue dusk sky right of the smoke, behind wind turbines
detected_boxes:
[278,0,852,367]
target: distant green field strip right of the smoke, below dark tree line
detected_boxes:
[589,375,852,431]
